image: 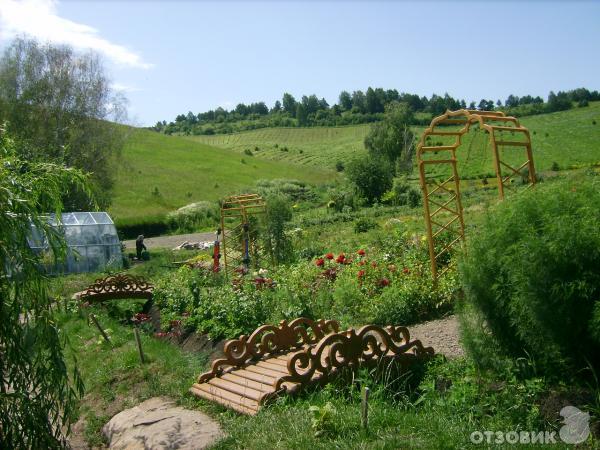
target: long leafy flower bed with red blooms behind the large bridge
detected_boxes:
[155,232,456,339]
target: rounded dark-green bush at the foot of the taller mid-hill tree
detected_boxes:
[346,156,393,204]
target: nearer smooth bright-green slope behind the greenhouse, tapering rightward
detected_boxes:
[110,129,331,223]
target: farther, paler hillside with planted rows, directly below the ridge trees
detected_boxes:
[188,102,600,176]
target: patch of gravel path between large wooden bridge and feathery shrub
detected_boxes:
[408,316,465,358]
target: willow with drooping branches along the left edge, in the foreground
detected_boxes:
[0,129,87,448]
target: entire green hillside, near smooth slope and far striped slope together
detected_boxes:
[110,102,600,222]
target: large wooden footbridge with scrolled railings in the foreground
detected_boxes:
[190,318,433,415]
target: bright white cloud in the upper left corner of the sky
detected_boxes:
[0,0,153,69]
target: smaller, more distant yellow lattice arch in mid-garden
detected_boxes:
[221,194,266,275]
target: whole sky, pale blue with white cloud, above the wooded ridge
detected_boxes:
[0,0,600,126]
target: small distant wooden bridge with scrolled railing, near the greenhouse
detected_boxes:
[72,274,154,302]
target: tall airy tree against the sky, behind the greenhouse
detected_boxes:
[0,38,125,210]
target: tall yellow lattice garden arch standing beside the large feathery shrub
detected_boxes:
[417,109,536,279]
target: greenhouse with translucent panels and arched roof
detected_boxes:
[29,212,123,274]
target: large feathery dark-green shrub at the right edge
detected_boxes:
[461,179,600,379]
